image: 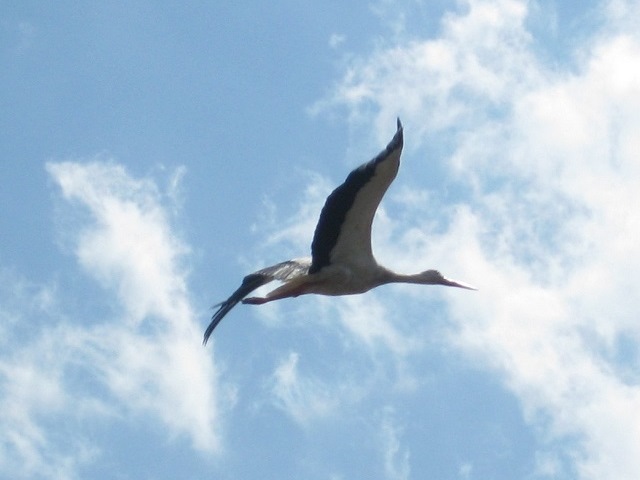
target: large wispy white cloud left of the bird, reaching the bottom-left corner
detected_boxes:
[0,162,225,478]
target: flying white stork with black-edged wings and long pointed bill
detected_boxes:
[203,119,476,345]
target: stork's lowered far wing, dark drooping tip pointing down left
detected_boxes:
[202,258,311,345]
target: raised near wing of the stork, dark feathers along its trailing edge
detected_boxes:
[309,119,403,273]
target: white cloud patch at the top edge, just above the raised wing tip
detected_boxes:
[312,0,539,142]
